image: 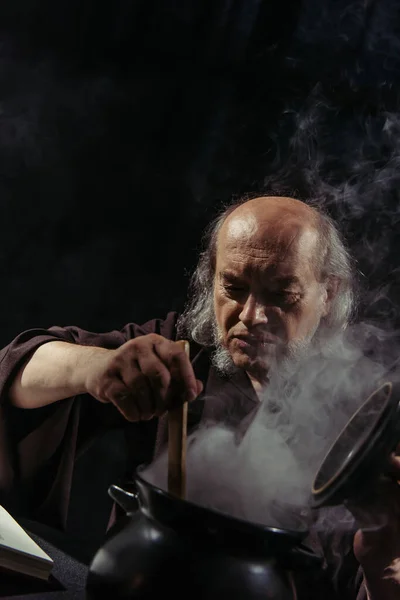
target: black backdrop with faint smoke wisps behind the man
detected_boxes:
[0,0,400,345]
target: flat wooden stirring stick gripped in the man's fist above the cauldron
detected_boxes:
[168,340,190,499]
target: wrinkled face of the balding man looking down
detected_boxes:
[214,216,329,380]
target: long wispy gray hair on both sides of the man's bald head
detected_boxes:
[177,196,355,348]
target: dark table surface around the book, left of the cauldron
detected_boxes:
[0,521,89,600]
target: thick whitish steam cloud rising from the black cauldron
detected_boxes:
[144,324,396,528]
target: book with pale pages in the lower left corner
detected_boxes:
[0,506,53,579]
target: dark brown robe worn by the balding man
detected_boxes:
[0,313,366,600]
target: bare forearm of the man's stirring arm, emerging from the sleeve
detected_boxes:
[9,341,109,408]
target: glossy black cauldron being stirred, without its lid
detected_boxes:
[87,471,319,600]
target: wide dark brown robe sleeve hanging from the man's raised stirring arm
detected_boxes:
[0,312,177,528]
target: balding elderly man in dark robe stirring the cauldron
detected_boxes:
[0,197,400,600]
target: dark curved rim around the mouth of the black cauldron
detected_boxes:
[135,464,309,544]
